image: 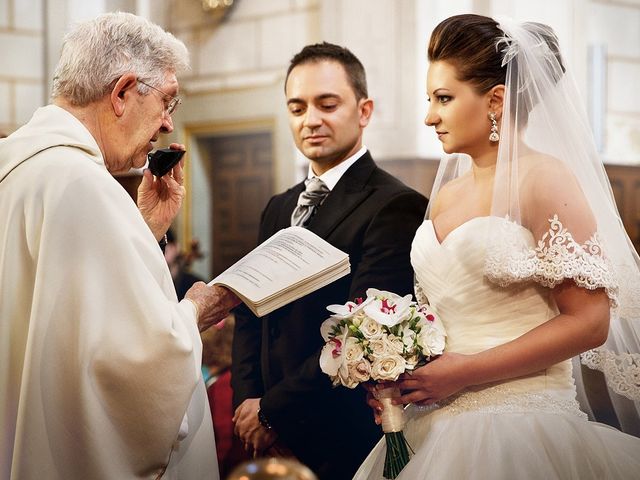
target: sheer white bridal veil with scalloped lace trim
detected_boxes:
[424,19,640,435]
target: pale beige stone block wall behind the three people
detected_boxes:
[0,0,640,162]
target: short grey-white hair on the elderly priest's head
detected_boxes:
[51,12,189,106]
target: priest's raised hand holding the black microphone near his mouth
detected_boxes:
[138,143,185,241]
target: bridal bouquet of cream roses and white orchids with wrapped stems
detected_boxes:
[320,288,446,479]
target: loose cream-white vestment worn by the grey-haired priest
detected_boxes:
[0,105,219,480]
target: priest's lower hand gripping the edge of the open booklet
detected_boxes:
[184,282,241,332]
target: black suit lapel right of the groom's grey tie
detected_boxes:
[308,151,376,238]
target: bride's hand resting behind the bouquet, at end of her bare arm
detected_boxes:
[392,352,469,405]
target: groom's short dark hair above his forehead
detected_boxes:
[284,42,369,100]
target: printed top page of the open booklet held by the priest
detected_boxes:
[209,227,348,302]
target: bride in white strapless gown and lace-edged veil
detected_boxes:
[354,15,640,480]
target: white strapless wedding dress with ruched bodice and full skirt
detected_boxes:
[354,217,640,480]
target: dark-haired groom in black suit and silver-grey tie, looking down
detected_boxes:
[232,43,427,480]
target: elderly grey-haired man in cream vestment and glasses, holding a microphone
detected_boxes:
[0,13,238,480]
